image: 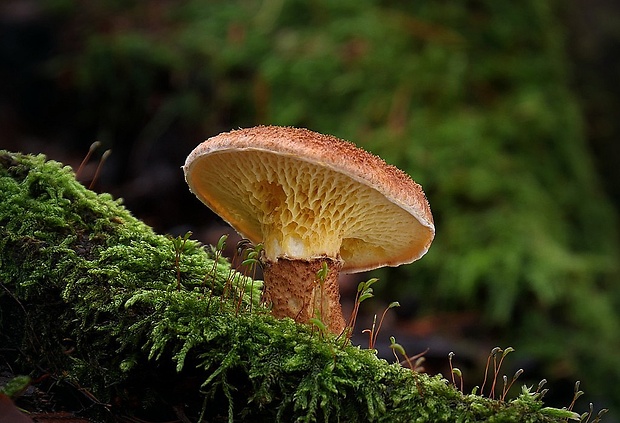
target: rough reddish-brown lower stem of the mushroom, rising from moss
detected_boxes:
[263,257,345,334]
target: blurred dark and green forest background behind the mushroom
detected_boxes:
[0,0,620,421]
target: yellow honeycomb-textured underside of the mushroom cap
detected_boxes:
[193,150,424,270]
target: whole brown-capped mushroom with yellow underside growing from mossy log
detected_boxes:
[183,126,435,334]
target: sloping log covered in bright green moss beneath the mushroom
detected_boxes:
[0,151,575,422]
